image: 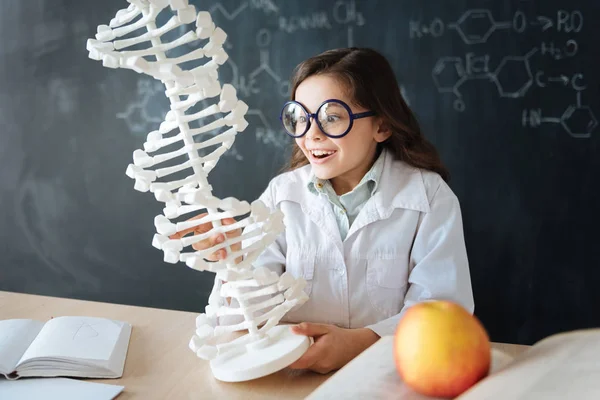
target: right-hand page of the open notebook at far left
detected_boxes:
[19,317,125,365]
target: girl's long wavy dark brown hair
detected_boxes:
[287,47,450,181]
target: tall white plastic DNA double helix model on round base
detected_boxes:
[87,0,310,382]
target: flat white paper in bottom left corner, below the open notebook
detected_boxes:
[0,378,124,400]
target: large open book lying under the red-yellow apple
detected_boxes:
[306,329,600,400]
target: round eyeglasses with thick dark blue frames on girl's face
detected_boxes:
[279,99,375,139]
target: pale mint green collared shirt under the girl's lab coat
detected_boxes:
[307,151,386,240]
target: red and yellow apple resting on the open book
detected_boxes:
[394,300,491,398]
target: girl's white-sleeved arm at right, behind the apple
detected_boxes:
[367,182,474,336]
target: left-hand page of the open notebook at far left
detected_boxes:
[0,319,44,374]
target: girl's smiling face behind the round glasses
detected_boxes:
[294,75,391,195]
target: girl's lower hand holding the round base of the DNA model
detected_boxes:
[289,322,379,374]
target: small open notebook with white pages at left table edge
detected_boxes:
[0,317,131,379]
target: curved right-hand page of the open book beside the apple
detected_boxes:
[459,329,600,400]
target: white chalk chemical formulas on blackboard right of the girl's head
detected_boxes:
[408,5,598,138]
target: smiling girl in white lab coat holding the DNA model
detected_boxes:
[172,48,474,373]
